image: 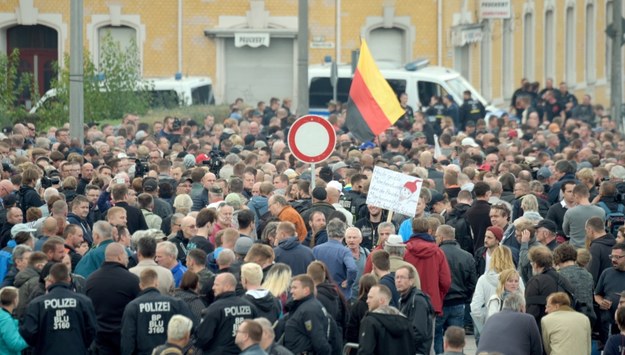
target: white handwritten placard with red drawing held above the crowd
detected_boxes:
[367,166,423,217]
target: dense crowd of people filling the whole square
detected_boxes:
[0,81,625,355]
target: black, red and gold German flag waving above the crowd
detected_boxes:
[345,40,405,142]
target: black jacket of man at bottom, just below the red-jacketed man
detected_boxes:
[399,287,435,354]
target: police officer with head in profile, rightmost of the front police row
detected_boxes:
[284,275,332,354]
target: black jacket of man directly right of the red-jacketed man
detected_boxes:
[440,240,477,306]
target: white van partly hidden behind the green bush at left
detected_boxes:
[29,77,215,114]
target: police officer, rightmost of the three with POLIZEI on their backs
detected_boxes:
[195,272,257,354]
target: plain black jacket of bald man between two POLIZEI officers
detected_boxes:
[86,262,141,354]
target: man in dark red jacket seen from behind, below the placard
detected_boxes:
[404,217,451,316]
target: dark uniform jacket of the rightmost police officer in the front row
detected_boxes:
[284,295,331,355]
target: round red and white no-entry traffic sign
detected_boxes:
[288,115,336,163]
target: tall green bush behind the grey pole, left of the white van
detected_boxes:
[37,32,150,126]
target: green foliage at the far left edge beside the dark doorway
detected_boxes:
[0,49,38,126]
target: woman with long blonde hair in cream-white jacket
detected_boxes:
[471,245,525,339]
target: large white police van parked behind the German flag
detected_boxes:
[308,61,496,116]
